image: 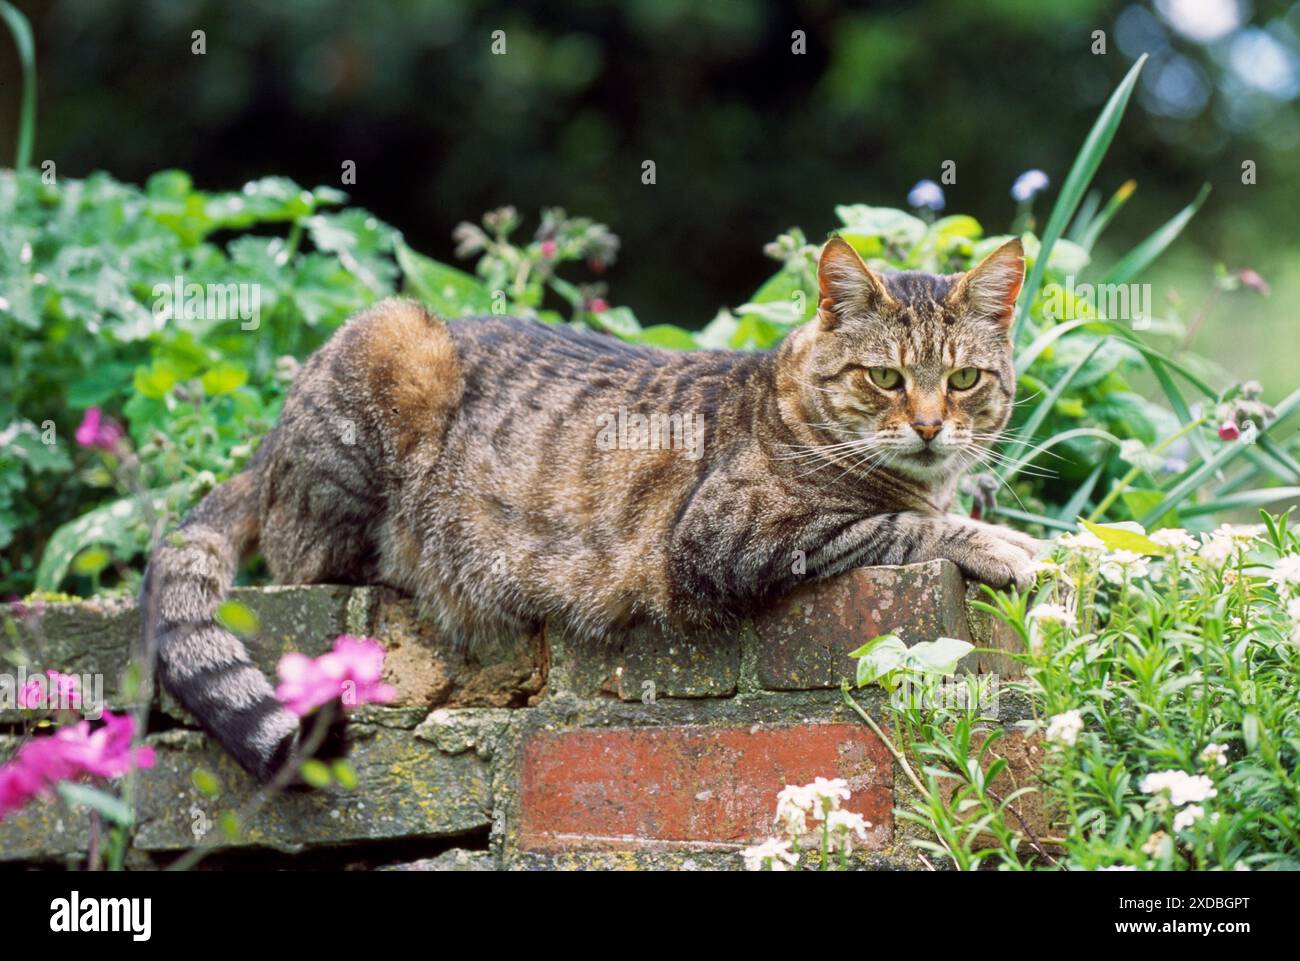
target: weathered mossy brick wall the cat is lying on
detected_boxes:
[0,562,1035,870]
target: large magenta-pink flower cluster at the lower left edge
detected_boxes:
[0,711,156,818]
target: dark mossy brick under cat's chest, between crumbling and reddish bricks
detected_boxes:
[546,624,741,702]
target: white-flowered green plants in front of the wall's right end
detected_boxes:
[852,514,1300,870]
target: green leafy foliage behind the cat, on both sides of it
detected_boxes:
[0,16,1300,593]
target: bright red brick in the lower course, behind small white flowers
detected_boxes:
[519,724,893,850]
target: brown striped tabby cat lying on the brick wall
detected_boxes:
[143,238,1037,779]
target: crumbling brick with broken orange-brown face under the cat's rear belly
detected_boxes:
[350,588,547,709]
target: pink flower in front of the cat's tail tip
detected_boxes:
[276,635,397,717]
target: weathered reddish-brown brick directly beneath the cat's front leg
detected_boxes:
[754,560,970,691]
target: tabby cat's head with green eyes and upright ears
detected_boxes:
[780,237,1024,484]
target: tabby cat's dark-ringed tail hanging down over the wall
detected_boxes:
[140,471,299,782]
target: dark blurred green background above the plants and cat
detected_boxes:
[0,0,1300,398]
